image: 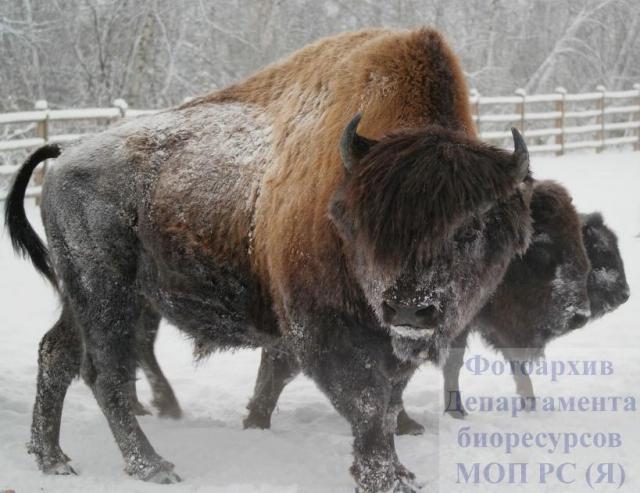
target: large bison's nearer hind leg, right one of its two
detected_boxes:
[64,266,180,484]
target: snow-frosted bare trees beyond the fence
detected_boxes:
[0,0,640,111]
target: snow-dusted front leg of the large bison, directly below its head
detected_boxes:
[300,328,417,493]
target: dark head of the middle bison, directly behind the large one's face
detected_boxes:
[477,181,591,357]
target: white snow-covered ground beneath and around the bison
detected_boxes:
[0,152,640,493]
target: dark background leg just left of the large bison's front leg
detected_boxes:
[244,347,300,429]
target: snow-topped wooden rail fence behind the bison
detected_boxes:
[0,84,640,200]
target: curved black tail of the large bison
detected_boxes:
[4,145,60,287]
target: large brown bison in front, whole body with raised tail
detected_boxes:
[6,30,532,492]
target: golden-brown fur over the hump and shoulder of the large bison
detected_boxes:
[186,28,475,320]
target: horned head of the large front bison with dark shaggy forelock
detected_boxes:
[330,116,532,357]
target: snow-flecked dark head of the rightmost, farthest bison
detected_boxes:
[581,213,629,318]
